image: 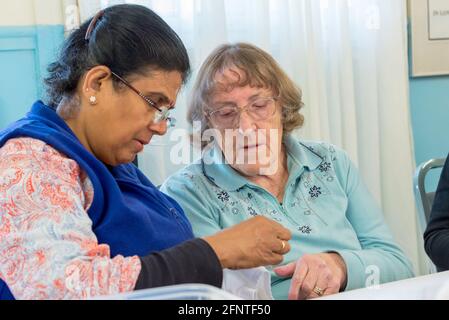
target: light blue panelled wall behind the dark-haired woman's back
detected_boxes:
[0,25,64,130]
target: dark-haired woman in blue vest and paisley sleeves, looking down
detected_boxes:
[0,5,290,299]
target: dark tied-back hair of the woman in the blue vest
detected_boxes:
[45,4,190,109]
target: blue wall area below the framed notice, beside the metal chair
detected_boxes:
[410,76,449,188]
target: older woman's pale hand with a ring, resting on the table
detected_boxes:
[274,253,347,300]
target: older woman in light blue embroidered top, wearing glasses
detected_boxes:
[162,43,413,299]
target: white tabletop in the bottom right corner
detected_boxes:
[321,271,449,300]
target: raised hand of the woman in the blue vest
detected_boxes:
[204,216,291,269]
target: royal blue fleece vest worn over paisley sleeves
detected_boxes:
[0,101,193,300]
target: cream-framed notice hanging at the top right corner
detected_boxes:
[408,0,449,77]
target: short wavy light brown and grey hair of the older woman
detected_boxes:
[188,43,304,141]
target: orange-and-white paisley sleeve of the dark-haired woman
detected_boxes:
[0,138,141,299]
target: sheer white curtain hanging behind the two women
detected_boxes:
[74,0,424,273]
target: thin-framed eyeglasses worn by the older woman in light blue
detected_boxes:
[207,97,278,129]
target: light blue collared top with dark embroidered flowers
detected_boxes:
[162,136,413,299]
